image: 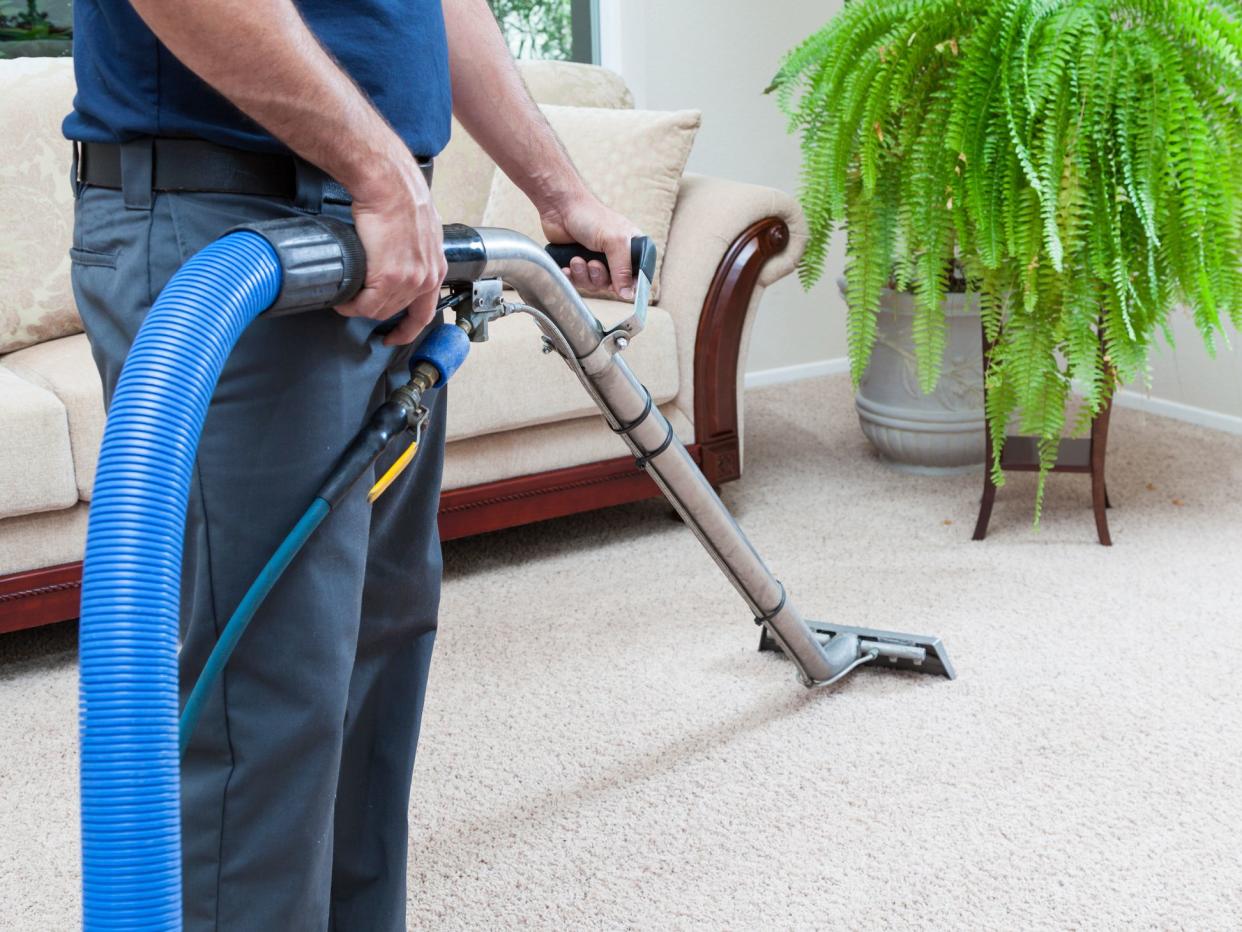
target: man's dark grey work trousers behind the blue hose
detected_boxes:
[71,176,446,932]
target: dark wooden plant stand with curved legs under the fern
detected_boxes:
[972,338,1113,547]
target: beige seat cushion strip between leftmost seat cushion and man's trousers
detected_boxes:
[0,333,103,502]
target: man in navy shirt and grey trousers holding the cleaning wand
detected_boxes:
[65,0,636,932]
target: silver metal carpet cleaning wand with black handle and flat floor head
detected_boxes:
[445,226,954,687]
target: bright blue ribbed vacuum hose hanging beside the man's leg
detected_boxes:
[81,232,281,932]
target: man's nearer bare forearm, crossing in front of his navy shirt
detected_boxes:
[132,0,405,194]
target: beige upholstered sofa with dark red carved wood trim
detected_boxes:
[0,60,804,631]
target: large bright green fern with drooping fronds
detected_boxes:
[769,0,1242,519]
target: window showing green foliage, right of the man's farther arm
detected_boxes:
[488,0,600,63]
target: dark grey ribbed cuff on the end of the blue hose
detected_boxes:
[229,216,366,317]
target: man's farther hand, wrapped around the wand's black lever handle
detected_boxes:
[539,193,641,301]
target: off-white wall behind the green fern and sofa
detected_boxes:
[600,0,1242,432]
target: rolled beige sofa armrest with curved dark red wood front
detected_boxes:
[661,174,806,483]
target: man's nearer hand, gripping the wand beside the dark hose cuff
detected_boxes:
[337,150,448,347]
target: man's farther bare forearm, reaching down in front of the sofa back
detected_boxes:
[443,0,584,208]
